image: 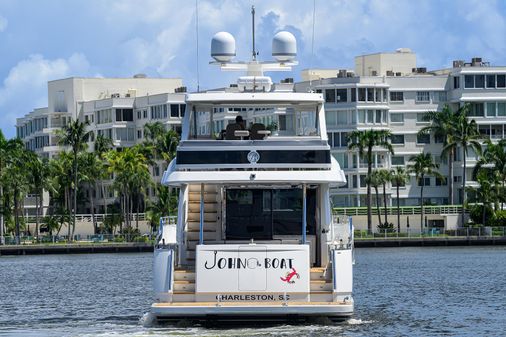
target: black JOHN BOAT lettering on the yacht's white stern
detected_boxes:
[204,250,293,269]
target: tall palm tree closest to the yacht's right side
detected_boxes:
[348,129,394,231]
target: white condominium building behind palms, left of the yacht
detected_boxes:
[16,74,185,215]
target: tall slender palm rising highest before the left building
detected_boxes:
[58,119,90,241]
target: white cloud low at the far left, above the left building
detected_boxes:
[0,53,90,136]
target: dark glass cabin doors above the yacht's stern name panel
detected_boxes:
[225,188,316,240]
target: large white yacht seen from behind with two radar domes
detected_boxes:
[151,27,354,321]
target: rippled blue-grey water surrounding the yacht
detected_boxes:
[0,247,506,336]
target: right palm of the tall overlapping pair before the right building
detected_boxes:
[443,104,482,226]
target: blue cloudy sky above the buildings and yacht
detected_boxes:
[0,0,506,137]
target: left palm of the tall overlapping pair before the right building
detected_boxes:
[418,104,460,205]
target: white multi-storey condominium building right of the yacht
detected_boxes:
[295,48,506,211]
